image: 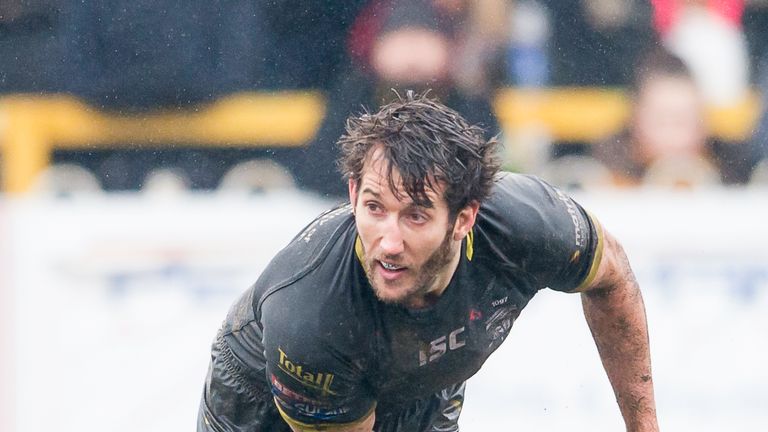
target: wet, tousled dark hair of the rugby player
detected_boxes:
[338,91,499,216]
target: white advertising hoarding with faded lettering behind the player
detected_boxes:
[0,191,768,432]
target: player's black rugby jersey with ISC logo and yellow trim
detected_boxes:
[206,173,602,430]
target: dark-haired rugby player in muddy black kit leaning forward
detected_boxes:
[198,92,658,432]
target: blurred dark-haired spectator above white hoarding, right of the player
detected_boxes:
[593,50,719,187]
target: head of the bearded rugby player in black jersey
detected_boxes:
[339,93,498,307]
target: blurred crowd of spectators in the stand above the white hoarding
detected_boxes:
[0,0,768,196]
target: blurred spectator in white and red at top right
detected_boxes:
[651,0,750,107]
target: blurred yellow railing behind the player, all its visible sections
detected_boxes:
[0,88,760,193]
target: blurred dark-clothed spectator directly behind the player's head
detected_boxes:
[297,0,508,197]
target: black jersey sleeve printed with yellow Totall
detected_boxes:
[262,289,376,430]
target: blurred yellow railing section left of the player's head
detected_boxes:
[0,92,325,193]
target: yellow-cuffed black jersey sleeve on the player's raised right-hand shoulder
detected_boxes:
[481,174,603,292]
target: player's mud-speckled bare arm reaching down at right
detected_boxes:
[581,228,659,432]
